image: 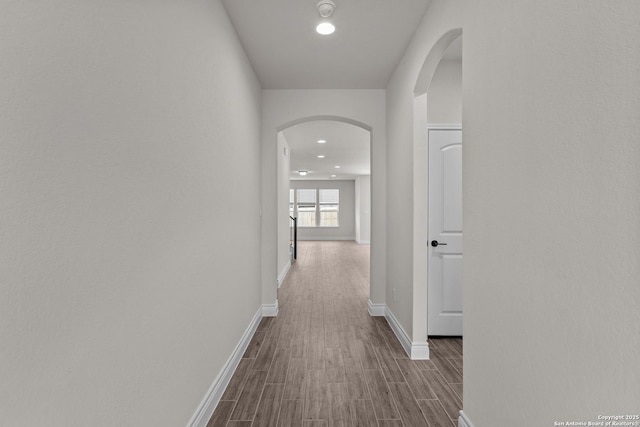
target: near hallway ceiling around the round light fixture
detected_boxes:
[222,0,431,89]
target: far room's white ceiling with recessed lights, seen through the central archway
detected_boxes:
[282,120,371,180]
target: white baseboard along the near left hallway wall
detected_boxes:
[187,308,262,427]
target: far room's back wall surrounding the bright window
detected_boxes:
[291,179,356,240]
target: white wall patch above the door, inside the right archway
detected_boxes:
[427,60,462,125]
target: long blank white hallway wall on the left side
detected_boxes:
[0,0,262,427]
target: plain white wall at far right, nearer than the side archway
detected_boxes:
[462,0,640,427]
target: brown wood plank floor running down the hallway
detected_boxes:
[207,242,462,427]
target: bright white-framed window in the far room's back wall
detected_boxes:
[289,188,340,227]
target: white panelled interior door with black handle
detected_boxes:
[427,129,462,336]
